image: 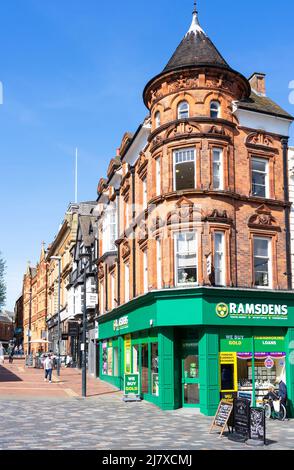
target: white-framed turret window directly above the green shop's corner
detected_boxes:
[175,232,198,286]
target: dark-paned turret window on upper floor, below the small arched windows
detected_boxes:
[174,148,196,191]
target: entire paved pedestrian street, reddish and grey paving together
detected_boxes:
[0,361,294,450]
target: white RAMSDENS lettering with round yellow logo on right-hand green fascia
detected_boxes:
[215,302,288,320]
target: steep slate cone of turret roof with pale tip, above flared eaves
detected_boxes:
[163,9,231,72]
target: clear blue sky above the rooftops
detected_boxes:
[0,0,294,309]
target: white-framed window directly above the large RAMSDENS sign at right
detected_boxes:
[253,237,272,287]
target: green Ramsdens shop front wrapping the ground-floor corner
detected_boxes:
[98,288,294,415]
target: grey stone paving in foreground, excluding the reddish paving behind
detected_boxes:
[0,396,294,450]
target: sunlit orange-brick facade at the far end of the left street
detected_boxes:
[23,244,48,354]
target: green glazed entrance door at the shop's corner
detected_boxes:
[182,340,200,408]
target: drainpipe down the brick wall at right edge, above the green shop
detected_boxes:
[282,137,292,290]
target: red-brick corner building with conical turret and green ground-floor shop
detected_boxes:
[97,11,294,415]
